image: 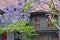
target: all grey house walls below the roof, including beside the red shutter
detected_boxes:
[0,12,60,40]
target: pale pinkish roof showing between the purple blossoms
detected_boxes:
[0,0,60,12]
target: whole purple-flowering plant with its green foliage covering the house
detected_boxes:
[0,0,60,40]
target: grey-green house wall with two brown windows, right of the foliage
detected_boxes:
[30,12,60,40]
